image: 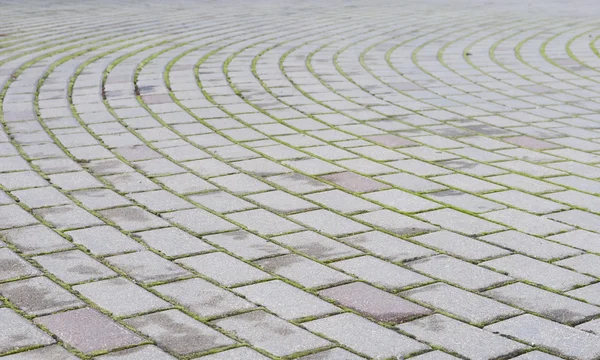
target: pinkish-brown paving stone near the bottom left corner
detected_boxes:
[35,308,145,354]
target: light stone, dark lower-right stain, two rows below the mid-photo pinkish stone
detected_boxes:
[354,209,438,235]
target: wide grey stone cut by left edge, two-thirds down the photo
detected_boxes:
[0,225,73,255]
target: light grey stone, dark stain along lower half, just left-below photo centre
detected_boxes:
[272,231,362,260]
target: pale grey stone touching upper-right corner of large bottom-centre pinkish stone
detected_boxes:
[407,255,512,291]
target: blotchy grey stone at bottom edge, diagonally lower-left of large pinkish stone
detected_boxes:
[214,311,330,357]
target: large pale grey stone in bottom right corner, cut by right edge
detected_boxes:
[485,314,600,360]
